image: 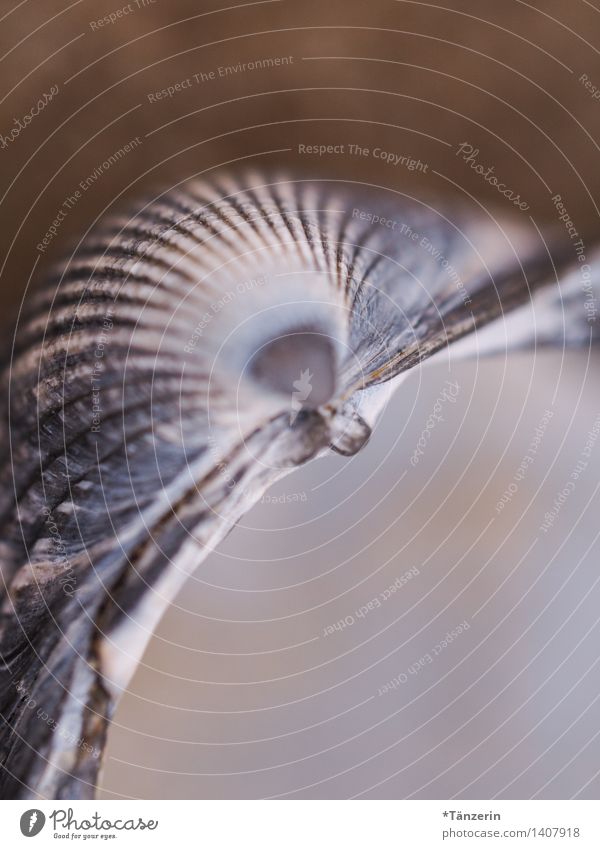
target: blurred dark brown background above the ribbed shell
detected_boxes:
[0,0,600,314]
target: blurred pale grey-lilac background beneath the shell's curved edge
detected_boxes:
[101,351,600,798]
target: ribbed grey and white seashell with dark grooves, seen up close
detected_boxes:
[0,174,599,798]
